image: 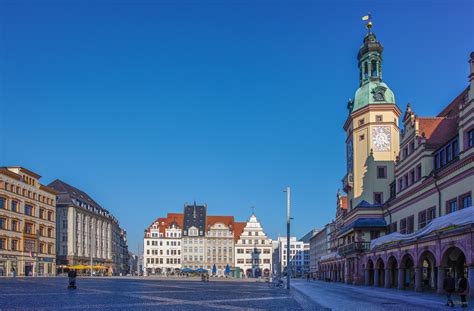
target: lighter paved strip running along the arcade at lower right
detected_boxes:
[292,280,474,311]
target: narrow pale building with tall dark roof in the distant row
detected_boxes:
[181,202,207,269]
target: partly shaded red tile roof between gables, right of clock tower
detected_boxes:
[417,117,458,147]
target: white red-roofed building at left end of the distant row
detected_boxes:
[143,213,183,276]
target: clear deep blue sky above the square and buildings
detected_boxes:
[0,0,474,251]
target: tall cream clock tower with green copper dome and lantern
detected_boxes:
[343,27,401,210]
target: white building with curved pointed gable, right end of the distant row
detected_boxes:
[235,214,273,278]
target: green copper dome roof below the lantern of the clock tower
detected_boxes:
[350,81,395,112]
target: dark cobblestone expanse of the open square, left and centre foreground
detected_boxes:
[0,277,318,311]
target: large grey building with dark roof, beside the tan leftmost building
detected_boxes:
[48,179,122,275]
